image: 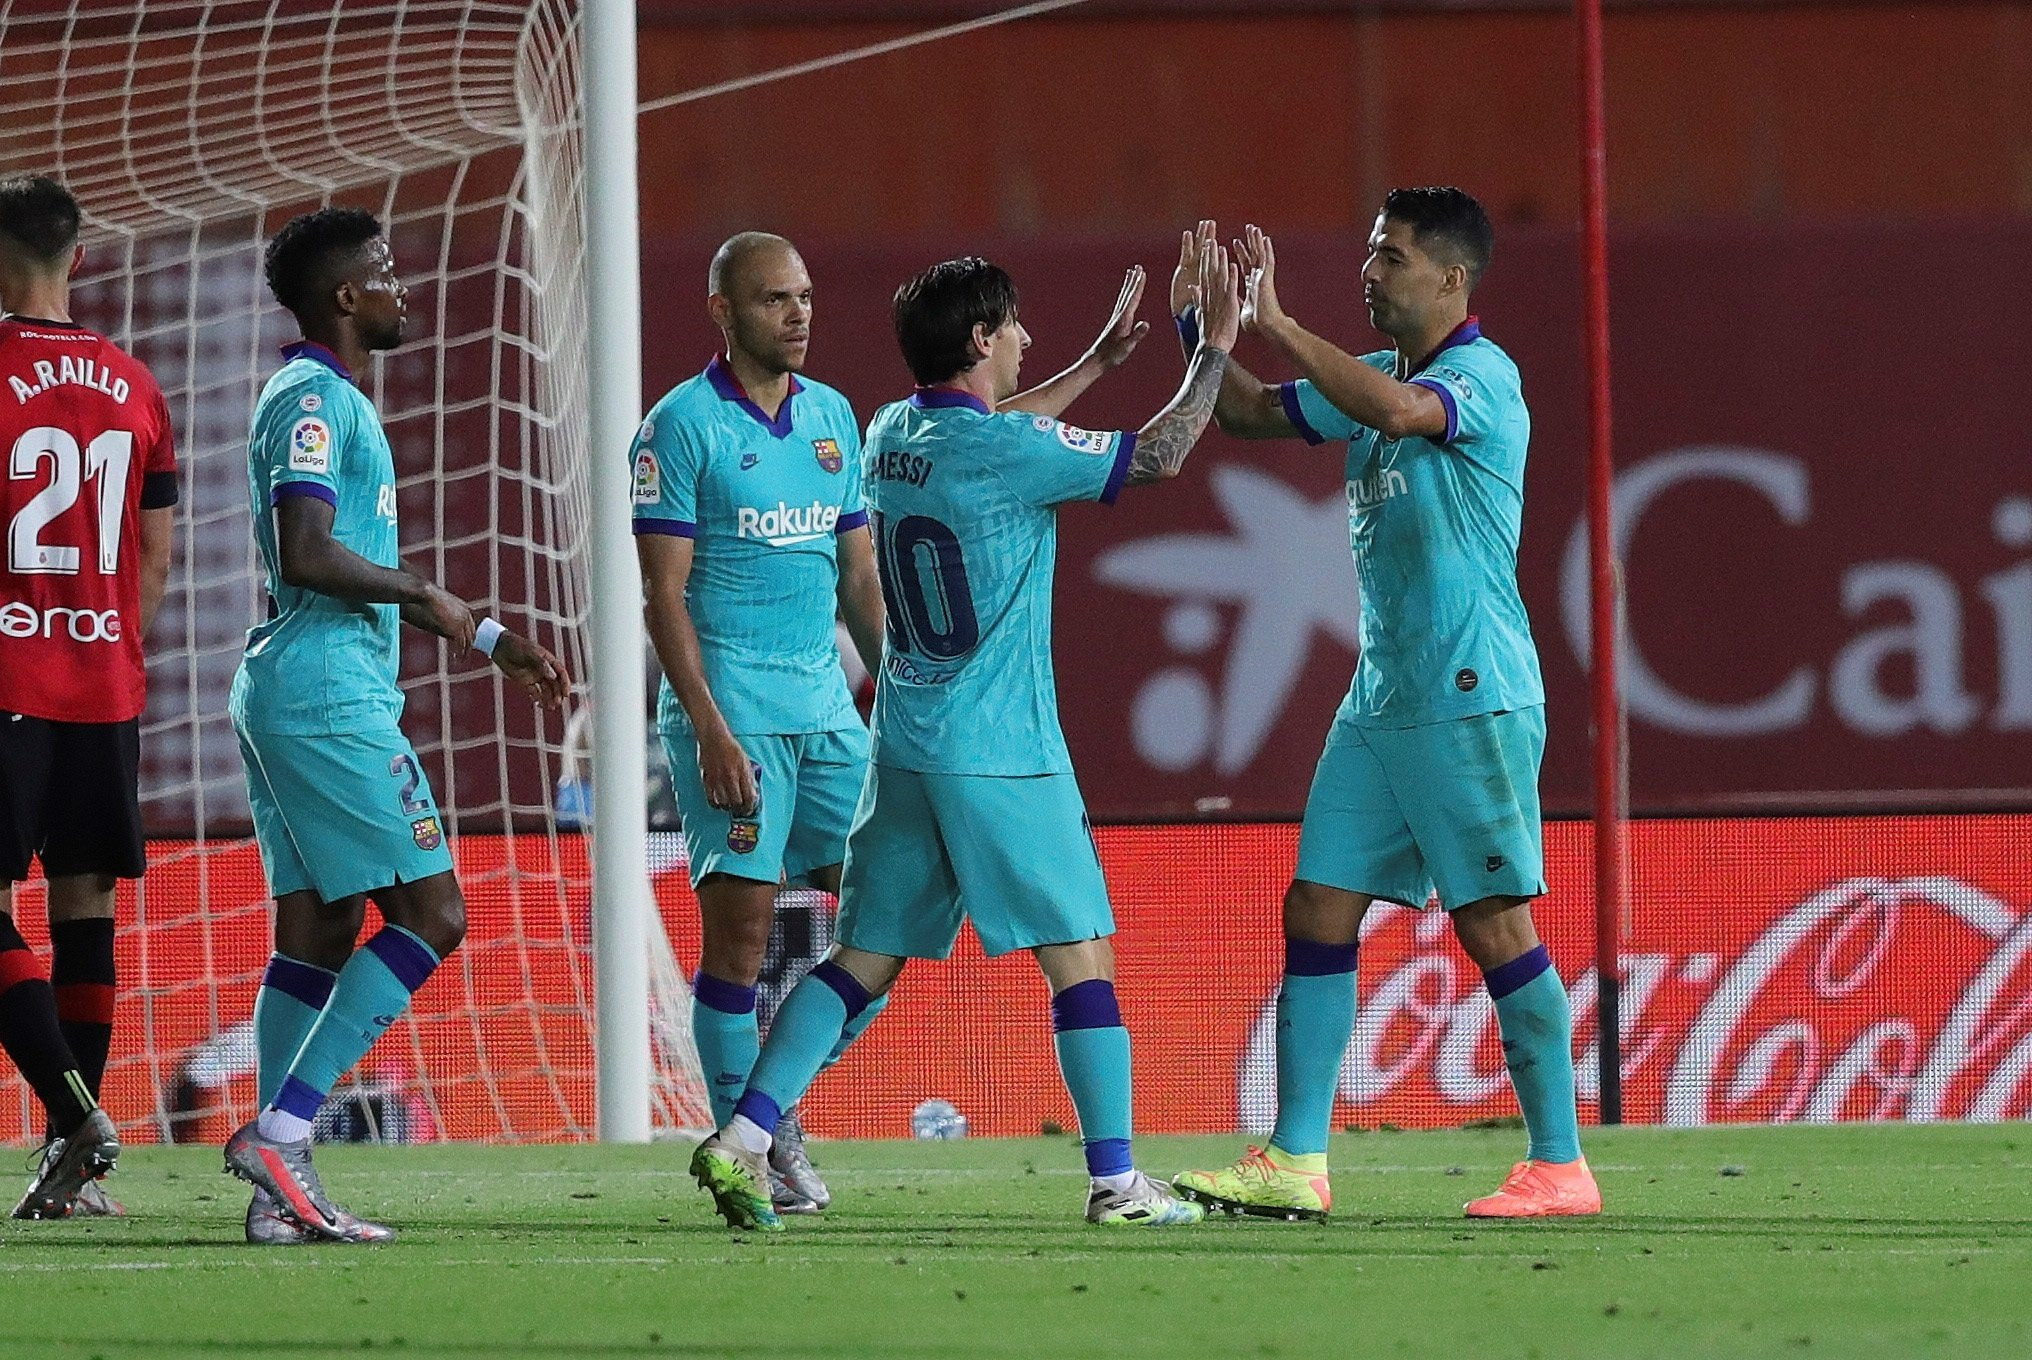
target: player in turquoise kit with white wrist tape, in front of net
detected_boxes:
[226,207,571,1244]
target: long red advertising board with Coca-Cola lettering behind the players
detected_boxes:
[0,815,2032,1140]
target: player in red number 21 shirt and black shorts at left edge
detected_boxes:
[0,175,177,1218]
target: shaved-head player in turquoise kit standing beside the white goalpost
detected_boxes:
[634,232,882,1214]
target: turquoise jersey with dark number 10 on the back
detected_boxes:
[868,388,1136,775]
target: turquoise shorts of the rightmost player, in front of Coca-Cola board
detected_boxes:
[1296,705,1544,911]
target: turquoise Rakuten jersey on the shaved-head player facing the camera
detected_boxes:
[632,358,868,736]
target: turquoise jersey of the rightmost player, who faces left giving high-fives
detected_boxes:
[1282,317,1544,728]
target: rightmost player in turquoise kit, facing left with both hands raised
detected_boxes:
[1172,189,1601,1218]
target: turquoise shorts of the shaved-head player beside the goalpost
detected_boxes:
[662,726,868,888]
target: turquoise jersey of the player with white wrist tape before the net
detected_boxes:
[232,342,402,734]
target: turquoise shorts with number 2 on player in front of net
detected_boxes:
[240,728,451,903]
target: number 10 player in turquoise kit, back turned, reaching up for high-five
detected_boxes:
[691,248,1240,1230]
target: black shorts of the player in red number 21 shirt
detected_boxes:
[0,709,148,882]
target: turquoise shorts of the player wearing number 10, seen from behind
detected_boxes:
[835,764,1116,960]
